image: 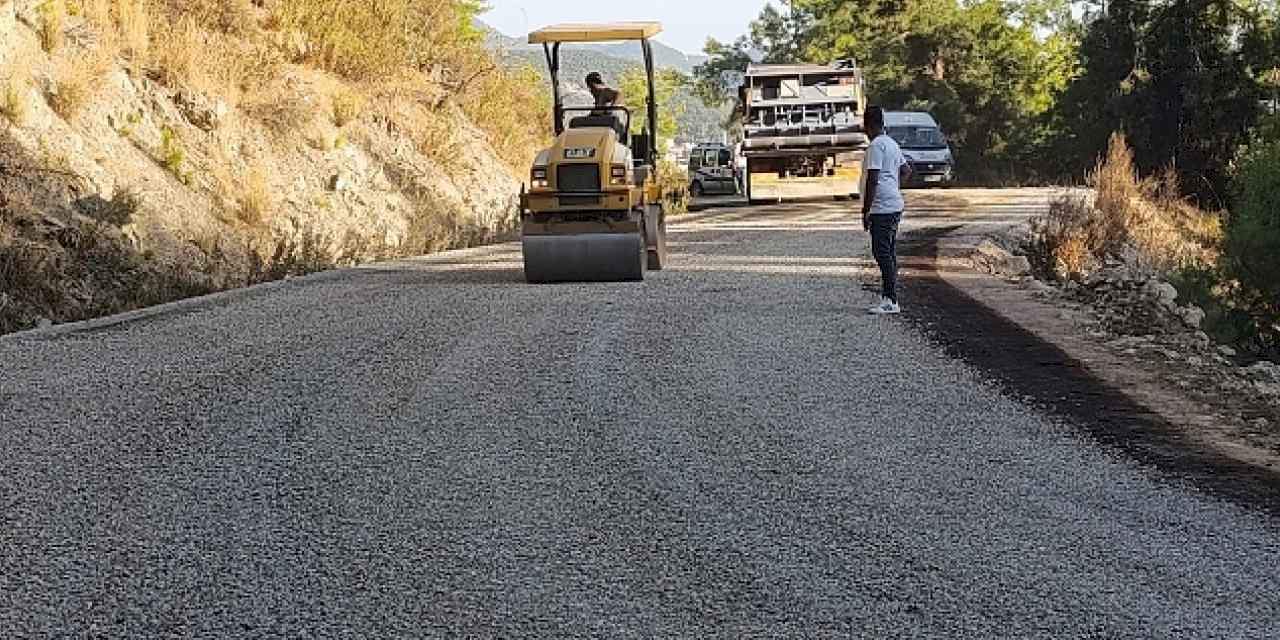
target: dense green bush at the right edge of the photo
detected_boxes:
[1222,141,1280,348]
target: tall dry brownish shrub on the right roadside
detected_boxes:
[1032,133,1222,278]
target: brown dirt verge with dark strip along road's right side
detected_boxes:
[885,192,1280,515]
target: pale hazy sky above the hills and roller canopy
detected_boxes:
[480,0,765,54]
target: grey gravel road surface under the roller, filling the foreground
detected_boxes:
[0,191,1280,639]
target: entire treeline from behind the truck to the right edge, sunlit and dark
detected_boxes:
[695,0,1280,351]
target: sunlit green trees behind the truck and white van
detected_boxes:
[695,0,1076,171]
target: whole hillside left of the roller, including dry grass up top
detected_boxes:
[0,0,549,333]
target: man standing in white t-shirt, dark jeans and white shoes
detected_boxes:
[863,106,911,315]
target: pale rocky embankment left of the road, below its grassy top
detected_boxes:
[0,0,520,333]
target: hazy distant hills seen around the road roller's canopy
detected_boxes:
[481,24,728,141]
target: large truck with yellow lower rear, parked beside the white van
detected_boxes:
[739,60,868,202]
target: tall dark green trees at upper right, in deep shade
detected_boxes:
[1051,0,1277,206]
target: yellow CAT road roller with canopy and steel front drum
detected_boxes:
[520,22,667,283]
